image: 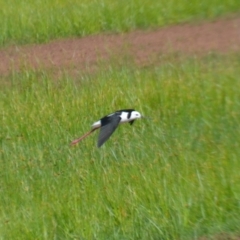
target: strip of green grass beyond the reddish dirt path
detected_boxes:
[0,0,240,46]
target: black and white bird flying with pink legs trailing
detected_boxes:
[71,109,143,147]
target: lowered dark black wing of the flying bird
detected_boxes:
[98,114,121,147]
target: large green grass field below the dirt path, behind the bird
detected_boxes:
[0,57,240,240]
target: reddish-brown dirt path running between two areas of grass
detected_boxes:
[0,17,240,75]
